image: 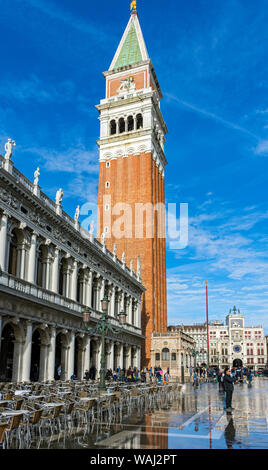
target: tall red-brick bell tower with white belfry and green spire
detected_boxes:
[97,9,167,367]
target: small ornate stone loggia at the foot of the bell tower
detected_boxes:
[151,327,195,382]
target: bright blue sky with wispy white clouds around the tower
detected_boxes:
[0,0,268,334]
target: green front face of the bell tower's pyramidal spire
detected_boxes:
[114,23,142,69]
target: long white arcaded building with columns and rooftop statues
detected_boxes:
[0,152,144,382]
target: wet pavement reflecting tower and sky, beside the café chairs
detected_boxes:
[33,378,268,449]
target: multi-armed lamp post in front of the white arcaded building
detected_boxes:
[82,295,126,393]
